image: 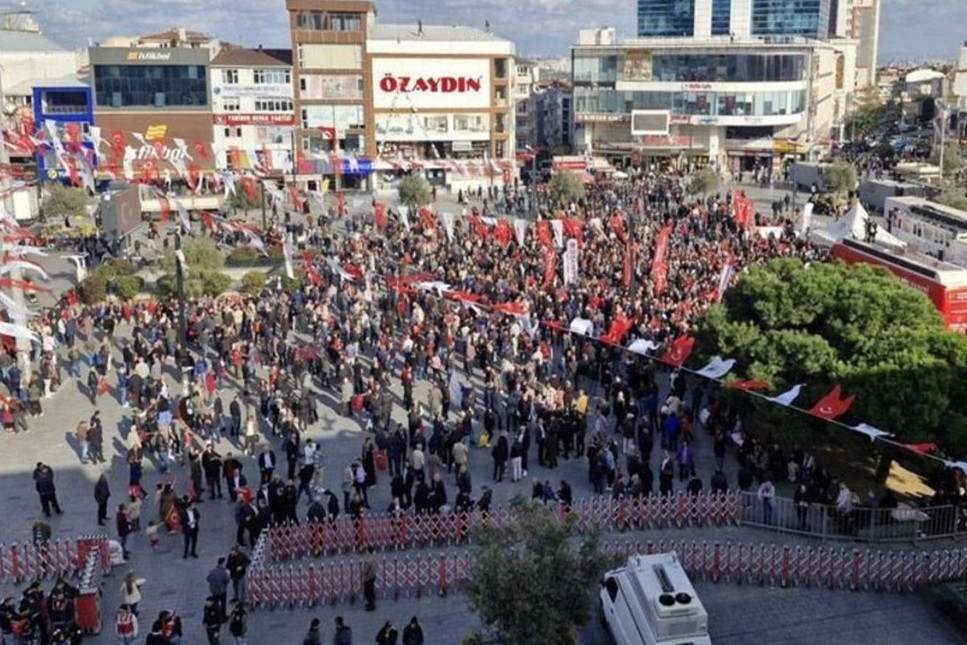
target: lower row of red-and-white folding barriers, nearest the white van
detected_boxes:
[248,540,967,609]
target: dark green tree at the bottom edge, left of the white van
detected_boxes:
[469,500,612,645]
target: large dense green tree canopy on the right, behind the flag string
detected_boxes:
[697,259,967,454]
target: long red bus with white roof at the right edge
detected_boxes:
[832,238,967,332]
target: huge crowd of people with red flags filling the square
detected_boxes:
[0,173,840,645]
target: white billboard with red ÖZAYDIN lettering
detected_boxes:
[372,58,491,110]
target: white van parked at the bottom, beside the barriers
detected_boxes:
[601,553,712,645]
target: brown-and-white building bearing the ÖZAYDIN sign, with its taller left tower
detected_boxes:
[286,0,515,188]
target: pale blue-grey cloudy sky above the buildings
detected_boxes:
[13,0,967,62]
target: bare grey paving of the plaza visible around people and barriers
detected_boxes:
[0,219,961,645]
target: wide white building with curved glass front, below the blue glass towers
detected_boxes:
[572,30,844,170]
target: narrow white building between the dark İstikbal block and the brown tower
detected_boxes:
[209,48,295,176]
